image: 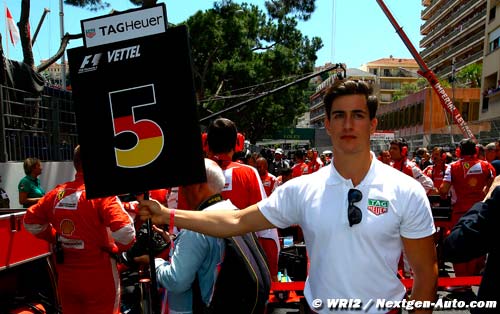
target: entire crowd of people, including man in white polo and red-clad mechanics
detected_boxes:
[20,80,500,314]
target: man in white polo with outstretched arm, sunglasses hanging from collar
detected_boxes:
[139,80,438,313]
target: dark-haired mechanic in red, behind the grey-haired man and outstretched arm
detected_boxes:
[204,118,280,280]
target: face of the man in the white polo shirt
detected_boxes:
[325,95,377,155]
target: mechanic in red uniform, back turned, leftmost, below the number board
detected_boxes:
[24,146,135,314]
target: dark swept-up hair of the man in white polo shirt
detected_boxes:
[323,80,378,119]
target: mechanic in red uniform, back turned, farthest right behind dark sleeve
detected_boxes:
[439,138,496,276]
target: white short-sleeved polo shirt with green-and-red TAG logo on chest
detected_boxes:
[258,158,435,313]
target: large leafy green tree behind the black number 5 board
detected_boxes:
[186,0,322,143]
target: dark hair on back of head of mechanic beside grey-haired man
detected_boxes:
[207,118,238,154]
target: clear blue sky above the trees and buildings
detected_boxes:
[0,0,423,68]
